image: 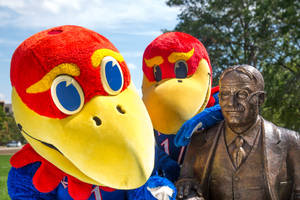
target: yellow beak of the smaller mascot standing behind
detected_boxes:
[142,59,211,134]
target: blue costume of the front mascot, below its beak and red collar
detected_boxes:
[7,162,176,200]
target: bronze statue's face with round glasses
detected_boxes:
[220,72,258,131]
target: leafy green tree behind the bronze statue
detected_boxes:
[167,0,300,130]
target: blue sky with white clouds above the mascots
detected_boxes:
[0,0,179,102]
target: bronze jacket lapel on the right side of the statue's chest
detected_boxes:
[261,118,283,200]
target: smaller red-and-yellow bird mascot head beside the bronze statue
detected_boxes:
[142,32,212,134]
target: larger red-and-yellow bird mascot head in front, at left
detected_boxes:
[11,26,154,189]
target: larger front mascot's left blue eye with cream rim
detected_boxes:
[51,75,84,115]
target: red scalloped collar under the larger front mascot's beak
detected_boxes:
[10,144,115,200]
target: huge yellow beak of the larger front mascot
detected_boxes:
[12,84,154,189]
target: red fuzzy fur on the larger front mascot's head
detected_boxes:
[10,26,130,119]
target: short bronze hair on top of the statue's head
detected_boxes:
[219,65,265,91]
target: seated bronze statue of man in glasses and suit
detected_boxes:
[176,65,300,200]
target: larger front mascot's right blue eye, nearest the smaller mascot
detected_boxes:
[101,56,124,95]
